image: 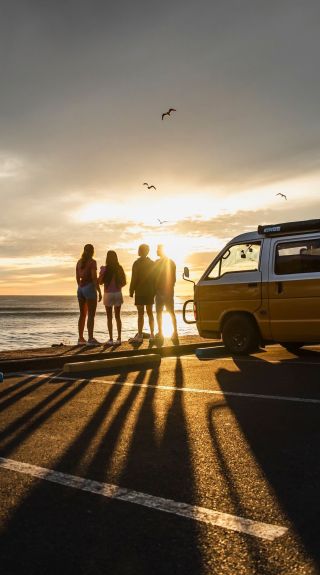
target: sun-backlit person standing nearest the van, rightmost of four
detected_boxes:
[155,244,179,345]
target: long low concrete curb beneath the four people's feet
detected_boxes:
[0,341,221,373]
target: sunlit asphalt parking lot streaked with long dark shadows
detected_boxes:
[0,346,320,575]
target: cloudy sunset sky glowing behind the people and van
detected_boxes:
[0,0,320,295]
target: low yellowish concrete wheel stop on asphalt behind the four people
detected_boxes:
[63,353,161,373]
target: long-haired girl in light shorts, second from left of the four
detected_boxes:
[98,250,127,345]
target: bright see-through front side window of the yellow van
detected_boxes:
[205,242,261,280]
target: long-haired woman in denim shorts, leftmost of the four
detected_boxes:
[76,244,102,345]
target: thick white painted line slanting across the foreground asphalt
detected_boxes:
[0,457,287,541]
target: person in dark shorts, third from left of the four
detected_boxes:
[129,244,154,343]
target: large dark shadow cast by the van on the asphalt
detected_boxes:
[212,358,320,567]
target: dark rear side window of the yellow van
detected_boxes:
[274,239,320,275]
